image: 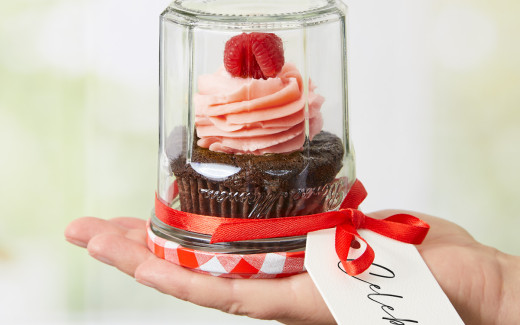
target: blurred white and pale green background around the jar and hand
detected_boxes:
[0,0,520,324]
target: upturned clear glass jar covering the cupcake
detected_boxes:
[151,0,355,254]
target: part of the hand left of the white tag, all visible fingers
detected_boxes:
[65,217,334,324]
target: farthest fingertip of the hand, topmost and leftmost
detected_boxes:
[65,217,125,247]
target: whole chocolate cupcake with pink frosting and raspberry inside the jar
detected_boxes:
[167,33,346,219]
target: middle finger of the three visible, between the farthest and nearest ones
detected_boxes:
[87,230,157,276]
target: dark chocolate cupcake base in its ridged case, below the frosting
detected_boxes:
[170,131,346,218]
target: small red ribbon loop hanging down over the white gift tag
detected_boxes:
[336,225,376,276]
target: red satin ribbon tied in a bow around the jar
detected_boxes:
[155,180,430,276]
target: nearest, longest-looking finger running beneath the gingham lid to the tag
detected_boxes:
[135,259,332,324]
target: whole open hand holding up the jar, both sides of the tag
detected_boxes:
[65,211,520,325]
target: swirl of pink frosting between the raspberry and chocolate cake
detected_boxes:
[194,63,324,155]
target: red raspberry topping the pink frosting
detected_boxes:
[224,33,285,79]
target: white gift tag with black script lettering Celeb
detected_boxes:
[305,229,464,325]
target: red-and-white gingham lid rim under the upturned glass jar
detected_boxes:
[147,221,305,279]
